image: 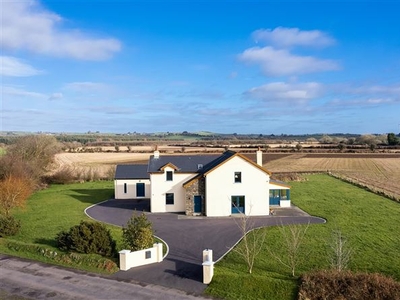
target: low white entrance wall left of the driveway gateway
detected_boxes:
[119,243,163,271]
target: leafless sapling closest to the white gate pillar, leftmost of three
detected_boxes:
[233,204,266,274]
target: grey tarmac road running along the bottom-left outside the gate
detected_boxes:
[0,255,206,300]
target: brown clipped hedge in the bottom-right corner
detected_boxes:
[298,271,400,300]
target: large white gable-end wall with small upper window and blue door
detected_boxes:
[206,156,269,216]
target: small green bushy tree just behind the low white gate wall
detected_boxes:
[122,213,154,251]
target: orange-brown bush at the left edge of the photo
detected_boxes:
[0,176,33,217]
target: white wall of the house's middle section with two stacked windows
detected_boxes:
[150,167,195,212]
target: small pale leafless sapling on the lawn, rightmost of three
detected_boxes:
[328,230,352,272]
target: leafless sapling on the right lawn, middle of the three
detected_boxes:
[268,223,310,277]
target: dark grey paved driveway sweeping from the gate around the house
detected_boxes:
[86,200,325,294]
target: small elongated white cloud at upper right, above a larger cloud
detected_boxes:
[252,27,335,48]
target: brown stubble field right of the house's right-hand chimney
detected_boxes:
[264,153,400,199]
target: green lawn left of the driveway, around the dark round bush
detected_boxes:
[0,181,122,272]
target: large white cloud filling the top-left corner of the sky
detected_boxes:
[0,1,121,60]
